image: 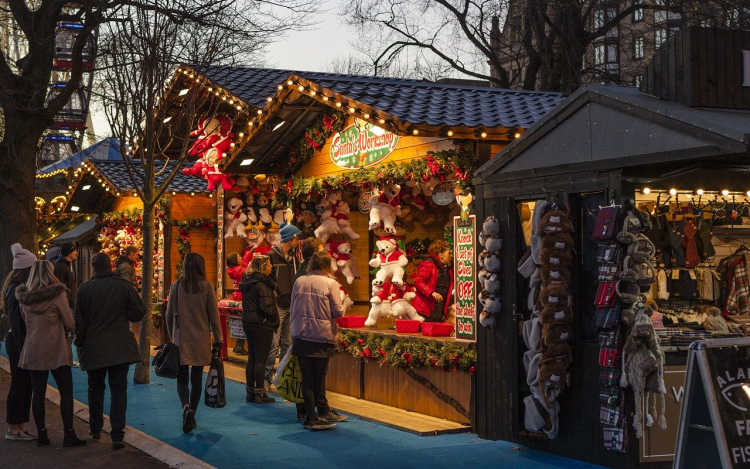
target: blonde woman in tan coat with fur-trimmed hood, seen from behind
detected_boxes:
[16,261,86,446]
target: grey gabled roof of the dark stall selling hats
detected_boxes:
[474,85,750,184]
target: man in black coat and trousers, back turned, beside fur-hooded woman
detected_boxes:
[75,253,146,449]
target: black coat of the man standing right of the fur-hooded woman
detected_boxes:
[75,271,146,371]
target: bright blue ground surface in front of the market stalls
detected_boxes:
[2,348,599,469]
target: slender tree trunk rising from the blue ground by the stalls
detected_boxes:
[133,203,156,384]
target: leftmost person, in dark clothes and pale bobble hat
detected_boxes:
[0,243,37,441]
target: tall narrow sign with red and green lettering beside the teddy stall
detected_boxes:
[453,215,477,342]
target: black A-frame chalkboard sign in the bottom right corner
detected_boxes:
[674,338,750,469]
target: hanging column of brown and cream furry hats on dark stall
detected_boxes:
[518,200,574,439]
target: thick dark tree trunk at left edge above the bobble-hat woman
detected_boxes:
[0,135,38,281]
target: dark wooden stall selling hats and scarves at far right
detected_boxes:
[474,28,750,468]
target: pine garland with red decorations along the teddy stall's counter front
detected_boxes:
[336,331,477,375]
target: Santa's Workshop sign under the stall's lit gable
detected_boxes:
[330,119,398,169]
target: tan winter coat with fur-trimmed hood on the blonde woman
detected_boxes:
[16,283,75,370]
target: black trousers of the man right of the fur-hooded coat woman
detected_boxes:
[88,363,130,441]
